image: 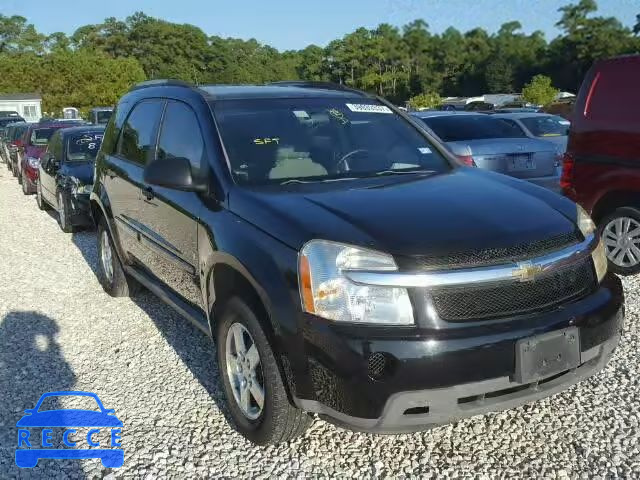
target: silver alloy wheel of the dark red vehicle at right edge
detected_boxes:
[602,217,640,268]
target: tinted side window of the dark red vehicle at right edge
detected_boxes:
[580,62,640,124]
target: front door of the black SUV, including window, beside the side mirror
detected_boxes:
[136,100,207,309]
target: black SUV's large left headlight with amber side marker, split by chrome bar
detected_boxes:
[298,240,414,325]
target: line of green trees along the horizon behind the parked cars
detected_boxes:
[0,0,640,112]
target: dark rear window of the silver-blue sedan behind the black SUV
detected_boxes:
[422,115,526,142]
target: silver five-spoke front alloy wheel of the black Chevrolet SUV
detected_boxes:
[225,322,264,420]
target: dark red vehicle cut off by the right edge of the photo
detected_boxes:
[561,55,640,275]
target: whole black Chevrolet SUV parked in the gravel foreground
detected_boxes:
[91,81,624,444]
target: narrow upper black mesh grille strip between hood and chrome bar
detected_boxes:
[408,231,582,269]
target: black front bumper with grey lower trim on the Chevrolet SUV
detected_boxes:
[294,275,624,433]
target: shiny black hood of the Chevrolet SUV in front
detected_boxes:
[229,168,576,255]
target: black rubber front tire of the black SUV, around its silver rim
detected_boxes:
[217,297,313,445]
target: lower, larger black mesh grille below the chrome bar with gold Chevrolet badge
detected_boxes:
[428,257,597,322]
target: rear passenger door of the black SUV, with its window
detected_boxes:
[103,98,165,263]
